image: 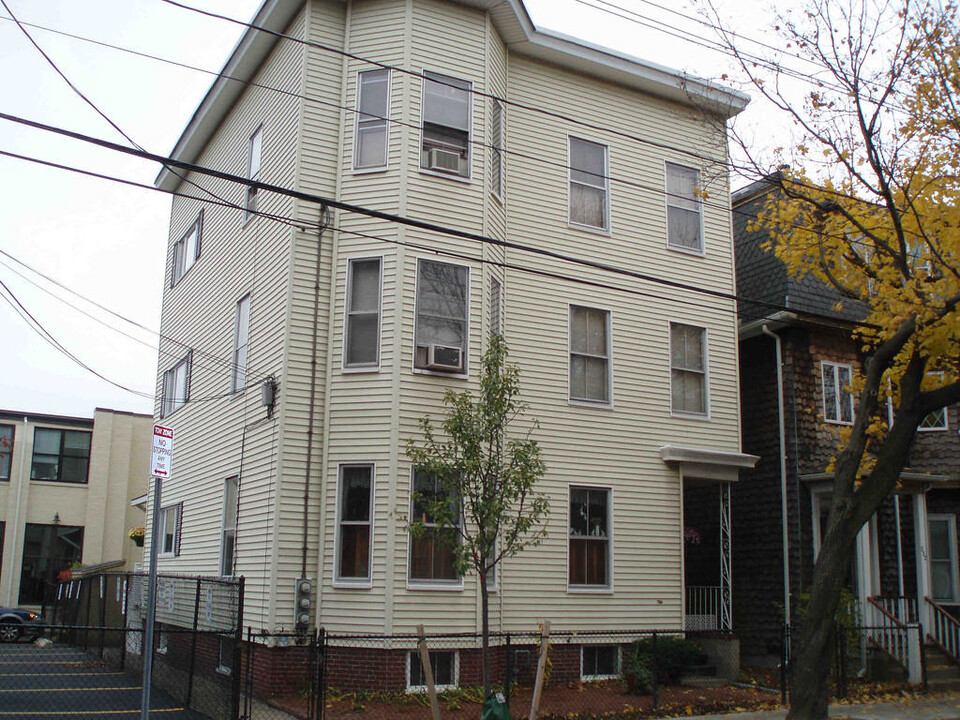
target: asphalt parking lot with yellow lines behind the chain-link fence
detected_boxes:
[0,642,206,720]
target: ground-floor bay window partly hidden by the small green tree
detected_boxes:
[410,470,460,582]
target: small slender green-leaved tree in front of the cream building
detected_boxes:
[407,335,548,699]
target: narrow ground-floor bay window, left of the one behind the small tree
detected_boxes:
[337,465,373,581]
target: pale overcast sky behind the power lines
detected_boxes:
[0,0,780,416]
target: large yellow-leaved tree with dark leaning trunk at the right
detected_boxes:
[714,0,960,720]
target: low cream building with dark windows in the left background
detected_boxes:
[0,408,152,608]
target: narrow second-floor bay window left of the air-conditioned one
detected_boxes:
[343,258,381,369]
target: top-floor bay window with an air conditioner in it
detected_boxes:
[420,71,471,177]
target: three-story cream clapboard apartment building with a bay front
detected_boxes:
[150,0,754,676]
